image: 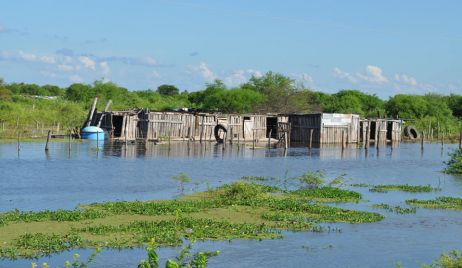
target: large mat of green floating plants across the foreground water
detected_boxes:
[0,182,383,259]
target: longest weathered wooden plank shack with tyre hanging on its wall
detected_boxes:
[92,109,277,142]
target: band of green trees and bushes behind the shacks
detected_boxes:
[0,72,462,130]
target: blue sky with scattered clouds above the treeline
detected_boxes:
[0,0,462,99]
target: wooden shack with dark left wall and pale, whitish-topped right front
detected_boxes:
[288,113,359,144]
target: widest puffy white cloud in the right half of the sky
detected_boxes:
[334,65,388,84]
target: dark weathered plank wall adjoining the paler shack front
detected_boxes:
[289,114,322,144]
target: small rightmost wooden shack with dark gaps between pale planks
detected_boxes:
[360,118,403,143]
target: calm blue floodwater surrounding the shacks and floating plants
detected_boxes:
[0,142,462,267]
